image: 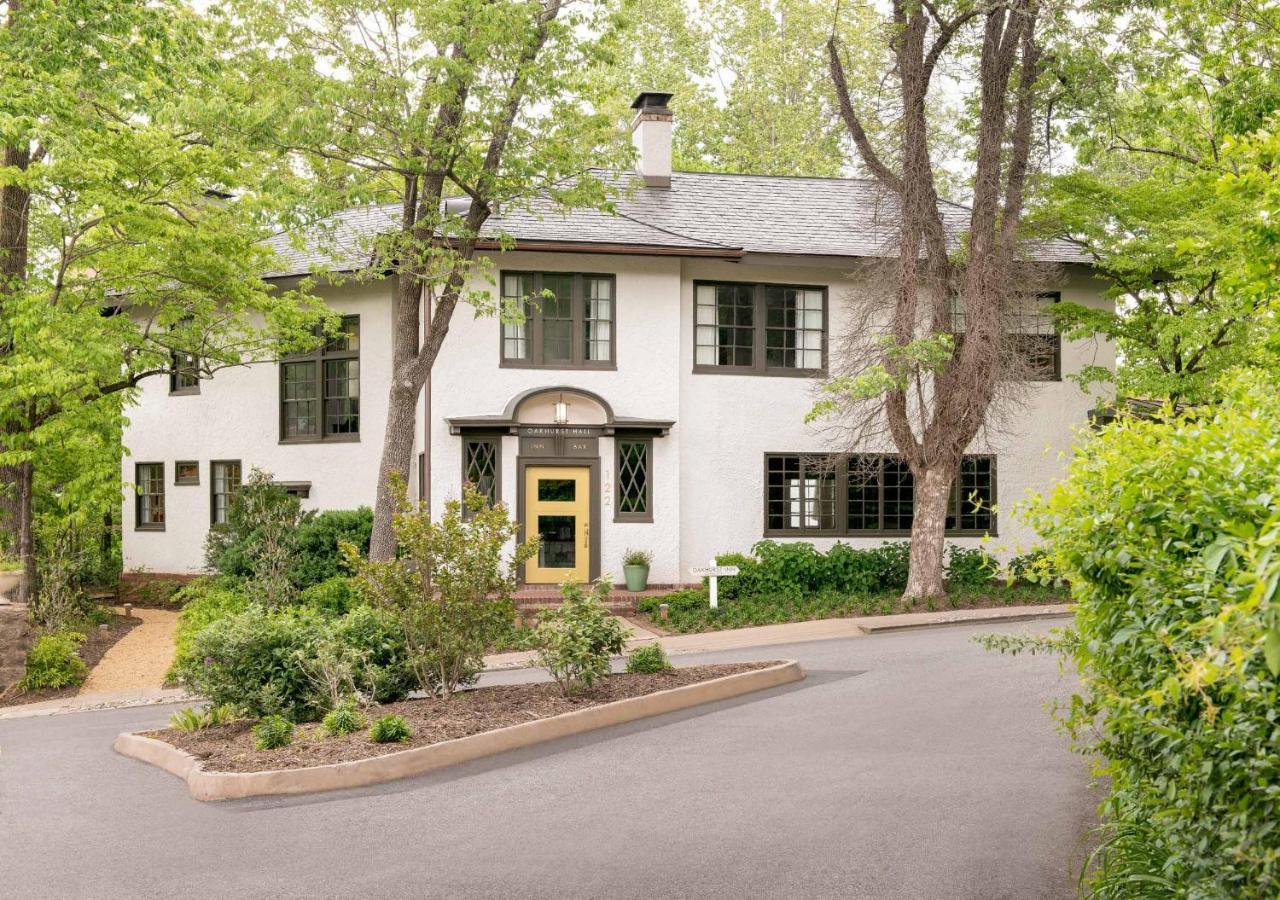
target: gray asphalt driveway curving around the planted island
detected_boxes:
[0,623,1097,900]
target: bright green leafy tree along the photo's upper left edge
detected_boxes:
[0,0,323,597]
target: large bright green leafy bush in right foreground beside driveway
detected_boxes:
[1033,379,1280,900]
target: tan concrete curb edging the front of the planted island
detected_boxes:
[114,659,804,800]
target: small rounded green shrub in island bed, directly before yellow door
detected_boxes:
[534,579,626,696]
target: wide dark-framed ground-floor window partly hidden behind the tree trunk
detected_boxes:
[764,453,996,536]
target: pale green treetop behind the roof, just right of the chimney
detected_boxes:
[614,0,884,177]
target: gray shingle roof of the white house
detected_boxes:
[264,172,1089,277]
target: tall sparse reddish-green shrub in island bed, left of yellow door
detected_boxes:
[344,483,538,696]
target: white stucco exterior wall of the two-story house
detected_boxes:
[117,252,1114,584]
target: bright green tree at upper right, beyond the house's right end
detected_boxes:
[1039,0,1280,402]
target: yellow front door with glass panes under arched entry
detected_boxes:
[525,466,591,584]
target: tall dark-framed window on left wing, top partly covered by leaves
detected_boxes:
[280,316,360,443]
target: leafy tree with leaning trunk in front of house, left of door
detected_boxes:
[222,0,623,559]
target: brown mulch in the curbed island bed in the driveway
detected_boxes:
[146,662,776,772]
